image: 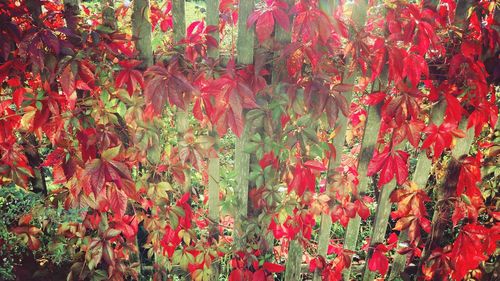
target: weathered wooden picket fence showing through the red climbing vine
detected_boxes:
[130,0,480,281]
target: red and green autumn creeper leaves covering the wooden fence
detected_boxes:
[0,0,500,281]
